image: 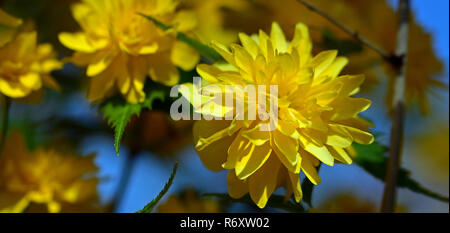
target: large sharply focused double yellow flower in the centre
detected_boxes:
[183,23,373,208]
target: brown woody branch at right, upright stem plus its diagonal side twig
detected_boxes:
[297,0,410,212]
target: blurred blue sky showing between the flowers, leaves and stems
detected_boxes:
[59,0,449,212]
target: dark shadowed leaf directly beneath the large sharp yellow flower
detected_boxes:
[202,193,305,213]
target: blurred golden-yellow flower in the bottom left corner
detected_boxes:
[0,132,98,213]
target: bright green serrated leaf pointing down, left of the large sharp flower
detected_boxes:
[99,90,165,155]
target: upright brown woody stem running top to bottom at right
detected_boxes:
[381,0,410,213]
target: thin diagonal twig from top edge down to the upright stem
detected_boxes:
[297,0,393,60]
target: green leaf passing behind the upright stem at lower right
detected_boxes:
[353,142,448,202]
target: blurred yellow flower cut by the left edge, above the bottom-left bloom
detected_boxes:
[0,28,62,98]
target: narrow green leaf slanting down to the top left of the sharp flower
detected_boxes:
[138,13,223,62]
